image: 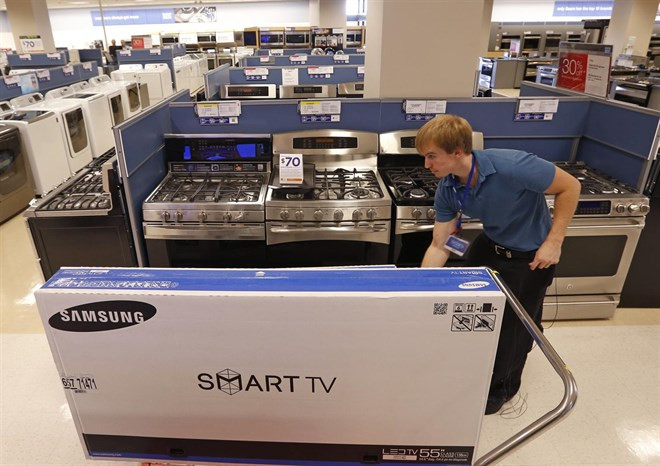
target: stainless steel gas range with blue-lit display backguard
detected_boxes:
[142,134,272,267]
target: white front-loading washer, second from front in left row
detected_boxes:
[0,109,71,196]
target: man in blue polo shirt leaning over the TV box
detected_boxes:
[416,115,580,414]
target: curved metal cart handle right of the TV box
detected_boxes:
[474,269,577,466]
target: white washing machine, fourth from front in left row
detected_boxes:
[62,92,115,158]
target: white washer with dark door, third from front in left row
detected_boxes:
[29,99,92,175]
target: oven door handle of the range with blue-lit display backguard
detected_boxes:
[144,223,266,240]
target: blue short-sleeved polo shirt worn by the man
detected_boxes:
[434,149,555,251]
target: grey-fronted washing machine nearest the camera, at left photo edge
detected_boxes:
[0,124,35,223]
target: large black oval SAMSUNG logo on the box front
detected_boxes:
[48,301,156,332]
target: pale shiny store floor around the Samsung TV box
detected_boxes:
[0,212,660,466]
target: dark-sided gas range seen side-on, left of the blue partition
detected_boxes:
[24,149,137,279]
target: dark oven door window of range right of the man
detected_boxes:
[555,235,628,277]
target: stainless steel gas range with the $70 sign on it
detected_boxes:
[266,130,391,267]
